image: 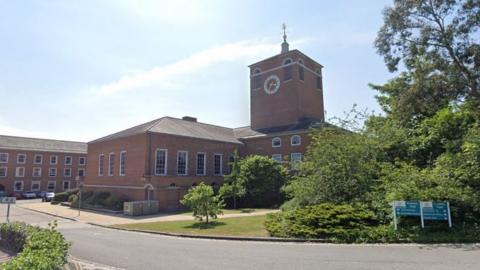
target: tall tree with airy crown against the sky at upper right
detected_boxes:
[374,0,480,121]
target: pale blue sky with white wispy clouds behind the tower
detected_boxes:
[0,0,393,141]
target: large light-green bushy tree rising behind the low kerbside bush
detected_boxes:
[284,128,378,207]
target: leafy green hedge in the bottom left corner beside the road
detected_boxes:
[0,222,70,270]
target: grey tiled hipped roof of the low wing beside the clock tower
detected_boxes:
[91,117,241,144]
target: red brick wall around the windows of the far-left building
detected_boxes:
[0,149,88,195]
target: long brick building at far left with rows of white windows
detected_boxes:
[0,135,87,195]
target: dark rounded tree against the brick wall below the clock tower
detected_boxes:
[240,156,289,207]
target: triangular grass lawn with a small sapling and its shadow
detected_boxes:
[115,216,268,237]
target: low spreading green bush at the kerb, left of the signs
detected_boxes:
[265,203,379,242]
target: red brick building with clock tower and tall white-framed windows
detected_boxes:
[84,33,324,210]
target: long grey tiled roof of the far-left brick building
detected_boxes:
[0,135,87,154]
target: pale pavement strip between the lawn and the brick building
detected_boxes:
[18,200,278,226]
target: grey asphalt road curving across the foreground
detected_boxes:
[0,200,480,270]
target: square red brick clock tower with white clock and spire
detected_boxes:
[249,25,324,131]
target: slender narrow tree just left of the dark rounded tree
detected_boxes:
[220,150,246,209]
